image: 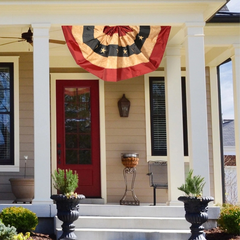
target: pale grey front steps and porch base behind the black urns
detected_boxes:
[0,200,220,240]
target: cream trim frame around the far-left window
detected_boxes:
[0,56,20,172]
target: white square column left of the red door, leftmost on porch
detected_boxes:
[32,24,52,203]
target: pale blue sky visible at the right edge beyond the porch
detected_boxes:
[220,0,240,119]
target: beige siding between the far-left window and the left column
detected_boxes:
[0,52,34,201]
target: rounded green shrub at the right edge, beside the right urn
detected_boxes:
[218,204,240,235]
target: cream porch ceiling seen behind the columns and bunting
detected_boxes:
[0,24,236,67]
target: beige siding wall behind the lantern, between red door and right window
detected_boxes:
[105,76,167,203]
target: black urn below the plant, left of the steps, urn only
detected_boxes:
[51,194,85,240]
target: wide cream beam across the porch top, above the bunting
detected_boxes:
[0,0,227,26]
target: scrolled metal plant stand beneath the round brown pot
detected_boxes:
[120,167,140,205]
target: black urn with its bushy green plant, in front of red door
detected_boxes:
[51,169,85,240]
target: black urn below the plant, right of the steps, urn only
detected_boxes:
[178,196,214,240]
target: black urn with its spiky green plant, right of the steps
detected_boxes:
[178,170,214,240]
